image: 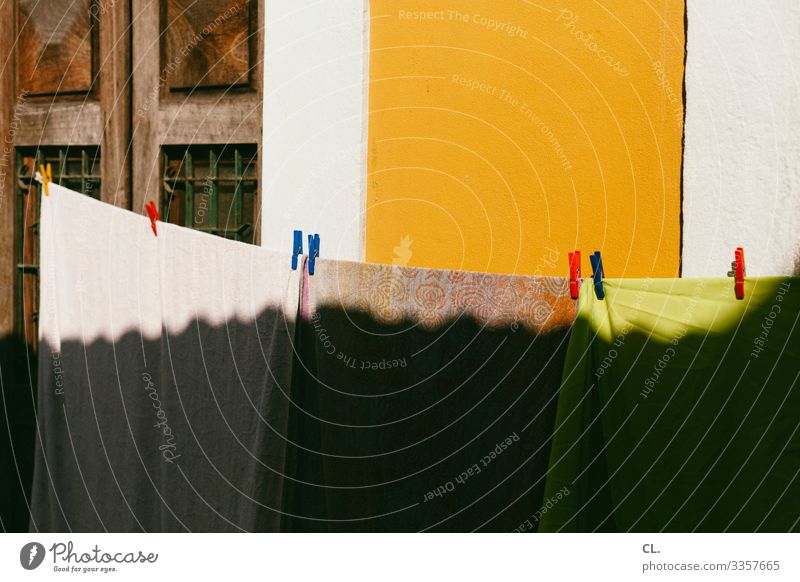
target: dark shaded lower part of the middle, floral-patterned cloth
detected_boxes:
[284,308,568,532]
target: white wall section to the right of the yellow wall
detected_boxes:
[683,0,800,277]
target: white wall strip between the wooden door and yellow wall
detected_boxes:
[262,0,369,260]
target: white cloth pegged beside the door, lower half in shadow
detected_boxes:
[31,184,300,532]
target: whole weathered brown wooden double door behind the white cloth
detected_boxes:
[0,0,263,352]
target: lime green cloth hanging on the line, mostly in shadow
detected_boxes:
[539,277,800,532]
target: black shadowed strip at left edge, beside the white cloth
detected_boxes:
[0,337,36,532]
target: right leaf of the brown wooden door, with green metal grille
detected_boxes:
[132,0,263,243]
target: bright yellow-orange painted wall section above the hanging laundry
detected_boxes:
[366,0,684,277]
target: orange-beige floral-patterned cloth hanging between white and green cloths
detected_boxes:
[285,259,575,531]
